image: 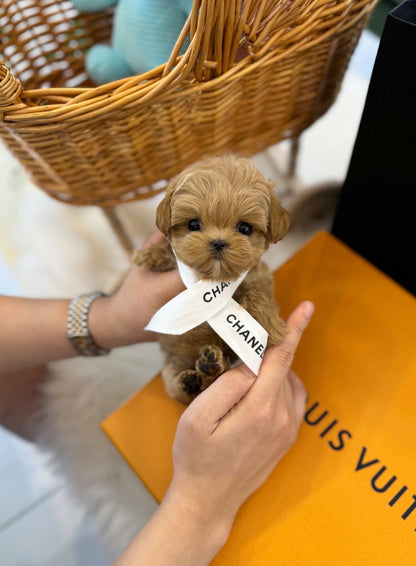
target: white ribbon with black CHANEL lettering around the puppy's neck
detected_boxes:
[145,261,268,375]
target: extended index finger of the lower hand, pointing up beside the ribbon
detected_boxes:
[247,301,314,403]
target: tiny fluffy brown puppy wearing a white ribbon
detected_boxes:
[134,156,289,404]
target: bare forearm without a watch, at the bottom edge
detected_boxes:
[113,488,232,566]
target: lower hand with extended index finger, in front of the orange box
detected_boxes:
[166,302,313,542]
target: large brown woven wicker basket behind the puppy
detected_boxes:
[0,0,376,207]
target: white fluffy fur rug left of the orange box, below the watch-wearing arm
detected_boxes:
[37,345,161,554]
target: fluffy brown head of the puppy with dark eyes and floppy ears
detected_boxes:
[157,157,289,281]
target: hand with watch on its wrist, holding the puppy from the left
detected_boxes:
[89,232,185,349]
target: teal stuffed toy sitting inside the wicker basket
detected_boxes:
[72,0,193,84]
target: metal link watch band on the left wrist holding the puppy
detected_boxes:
[67,291,110,356]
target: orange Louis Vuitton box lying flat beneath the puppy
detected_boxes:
[102,232,416,566]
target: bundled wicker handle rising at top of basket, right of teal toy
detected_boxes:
[163,0,276,81]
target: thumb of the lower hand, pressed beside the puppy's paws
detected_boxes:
[186,364,256,432]
